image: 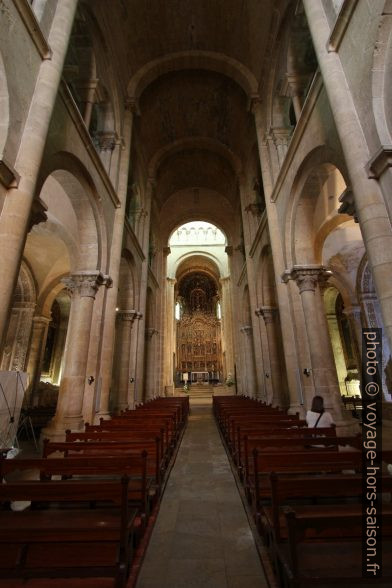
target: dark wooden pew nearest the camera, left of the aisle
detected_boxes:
[0,476,136,588]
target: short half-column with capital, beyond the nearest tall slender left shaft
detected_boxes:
[116,310,137,411]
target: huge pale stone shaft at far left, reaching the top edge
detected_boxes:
[0,0,78,344]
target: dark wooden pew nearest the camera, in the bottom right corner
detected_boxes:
[278,505,392,588]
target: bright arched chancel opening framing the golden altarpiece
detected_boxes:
[165,221,234,394]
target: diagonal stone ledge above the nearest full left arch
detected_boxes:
[59,80,121,208]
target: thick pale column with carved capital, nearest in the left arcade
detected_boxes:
[43,271,105,438]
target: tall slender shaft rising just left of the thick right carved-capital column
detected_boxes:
[252,99,301,414]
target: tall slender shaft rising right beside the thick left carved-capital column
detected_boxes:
[98,103,133,418]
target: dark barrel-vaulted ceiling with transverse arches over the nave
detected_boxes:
[85,0,290,229]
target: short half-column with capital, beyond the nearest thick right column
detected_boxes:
[256,306,283,406]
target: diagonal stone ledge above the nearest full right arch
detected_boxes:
[271,70,324,202]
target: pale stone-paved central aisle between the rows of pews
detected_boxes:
[136,400,267,588]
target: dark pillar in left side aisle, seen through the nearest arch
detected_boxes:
[24,316,51,405]
